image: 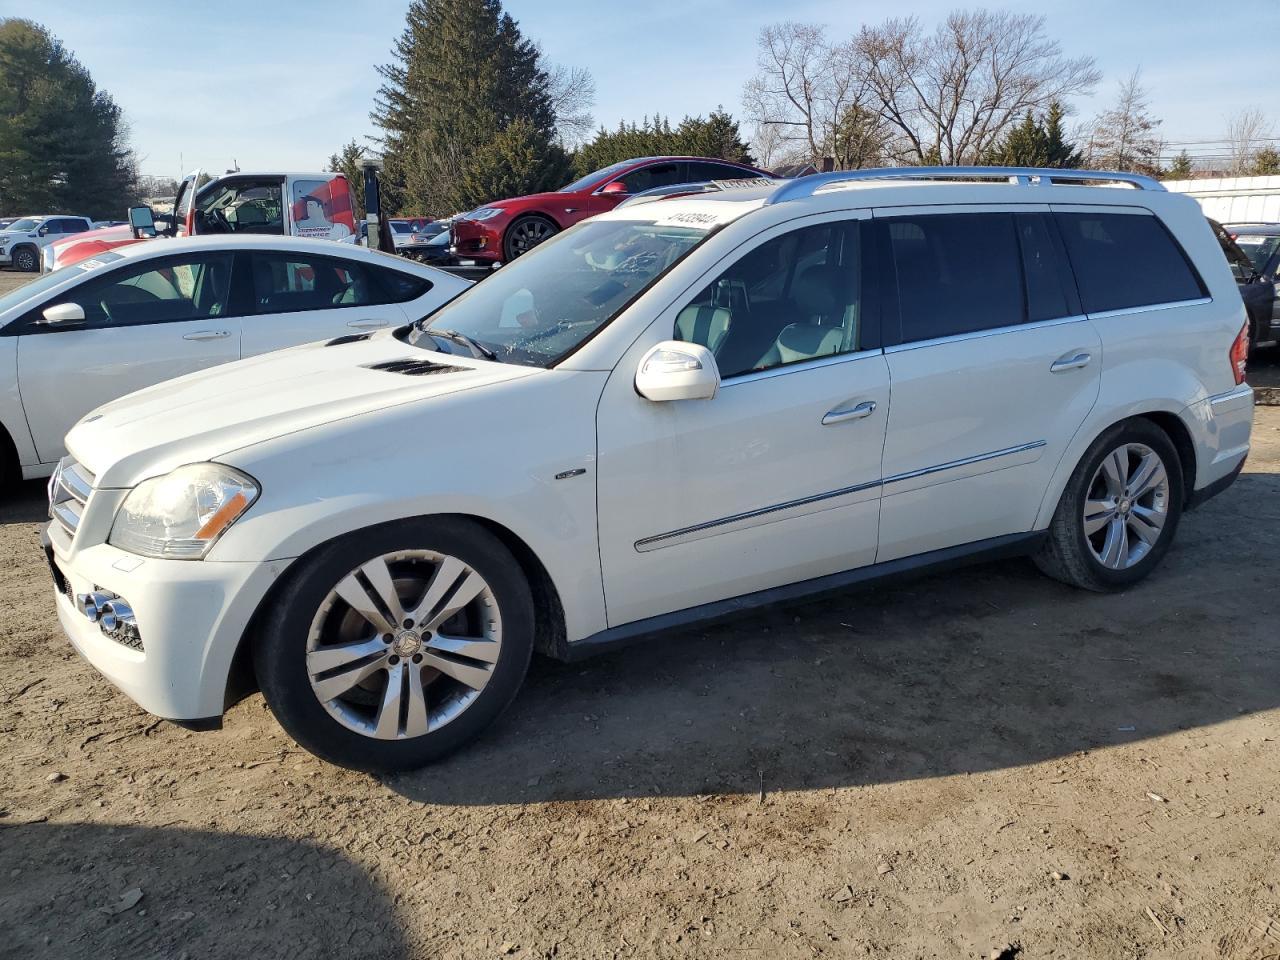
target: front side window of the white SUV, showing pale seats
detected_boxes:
[675,221,865,379]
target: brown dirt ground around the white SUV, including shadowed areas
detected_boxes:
[0,267,1280,960]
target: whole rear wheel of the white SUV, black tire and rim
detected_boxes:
[1034,419,1184,591]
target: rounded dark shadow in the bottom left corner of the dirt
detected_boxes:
[0,820,410,960]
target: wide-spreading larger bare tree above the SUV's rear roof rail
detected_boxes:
[852,10,1100,165]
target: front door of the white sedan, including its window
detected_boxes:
[15,252,241,463]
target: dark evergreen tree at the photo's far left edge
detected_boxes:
[0,19,137,219]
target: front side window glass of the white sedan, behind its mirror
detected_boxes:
[27,253,233,333]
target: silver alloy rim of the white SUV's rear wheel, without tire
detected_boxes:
[1082,443,1170,570]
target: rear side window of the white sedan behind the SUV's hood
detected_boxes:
[251,252,387,314]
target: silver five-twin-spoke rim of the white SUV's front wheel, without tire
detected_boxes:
[306,550,502,740]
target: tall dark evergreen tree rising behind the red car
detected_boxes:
[372,0,564,215]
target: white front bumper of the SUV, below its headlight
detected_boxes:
[41,525,289,721]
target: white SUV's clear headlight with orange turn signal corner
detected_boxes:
[108,463,259,559]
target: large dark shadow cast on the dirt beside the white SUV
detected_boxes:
[387,474,1280,804]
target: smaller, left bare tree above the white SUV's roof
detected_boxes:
[742,22,882,169]
